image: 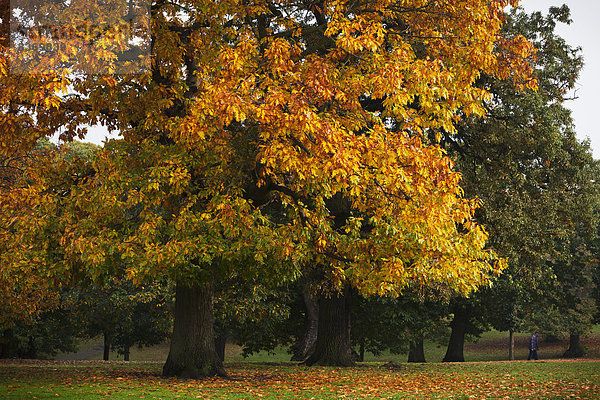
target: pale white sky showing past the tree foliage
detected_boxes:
[86,0,600,159]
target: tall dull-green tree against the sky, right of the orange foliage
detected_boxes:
[442,6,597,361]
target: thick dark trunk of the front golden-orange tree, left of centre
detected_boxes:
[163,282,225,379]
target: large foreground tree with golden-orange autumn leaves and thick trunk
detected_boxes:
[0,0,535,377]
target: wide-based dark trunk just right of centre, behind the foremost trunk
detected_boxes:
[305,289,354,367]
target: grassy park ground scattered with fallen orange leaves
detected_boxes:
[0,332,600,400]
